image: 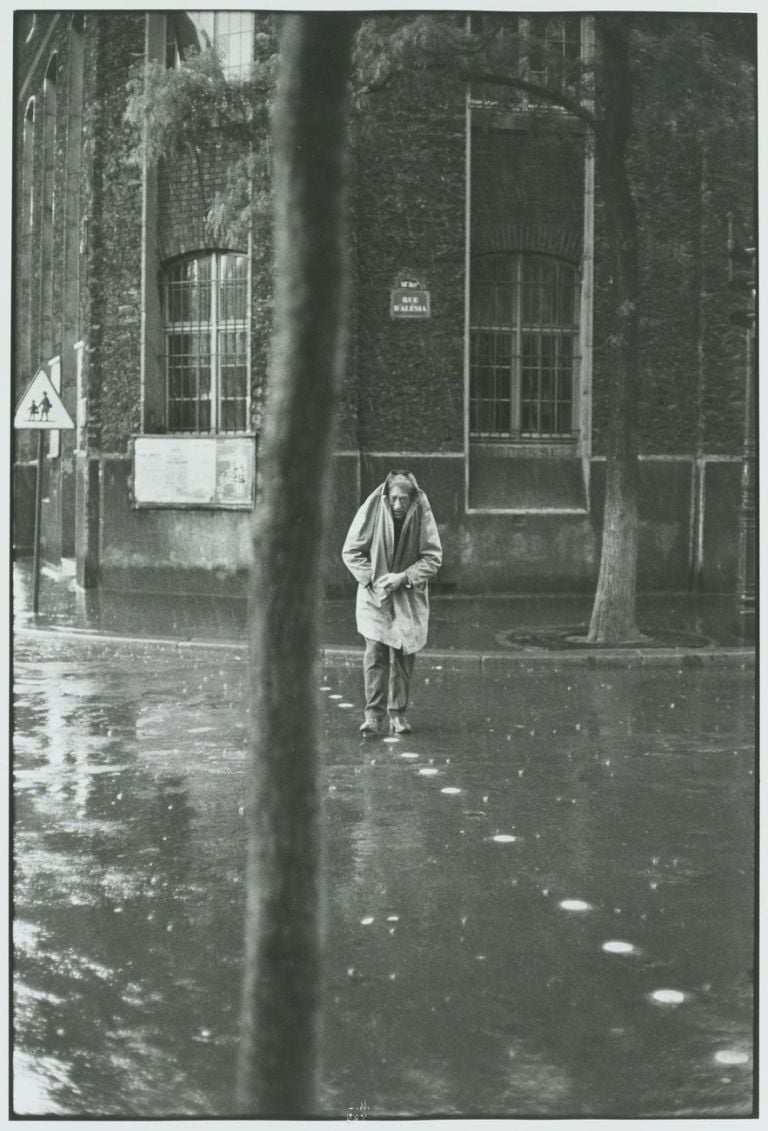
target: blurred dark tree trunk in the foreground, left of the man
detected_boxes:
[238,12,354,1117]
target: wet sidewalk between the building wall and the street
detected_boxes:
[14,560,754,666]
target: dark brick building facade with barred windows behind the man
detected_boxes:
[14,10,754,593]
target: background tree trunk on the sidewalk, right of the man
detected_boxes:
[587,14,640,644]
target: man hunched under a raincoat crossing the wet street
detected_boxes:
[342,470,442,734]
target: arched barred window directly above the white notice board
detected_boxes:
[162,251,250,432]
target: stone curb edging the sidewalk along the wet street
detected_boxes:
[14,624,756,673]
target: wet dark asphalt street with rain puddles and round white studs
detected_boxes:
[14,632,756,1119]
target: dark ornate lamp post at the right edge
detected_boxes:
[728,215,758,637]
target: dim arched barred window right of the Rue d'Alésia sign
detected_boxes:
[469,253,579,440]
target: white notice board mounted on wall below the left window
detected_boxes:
[132,435,256,509]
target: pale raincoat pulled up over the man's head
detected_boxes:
[342,476,442,653]
